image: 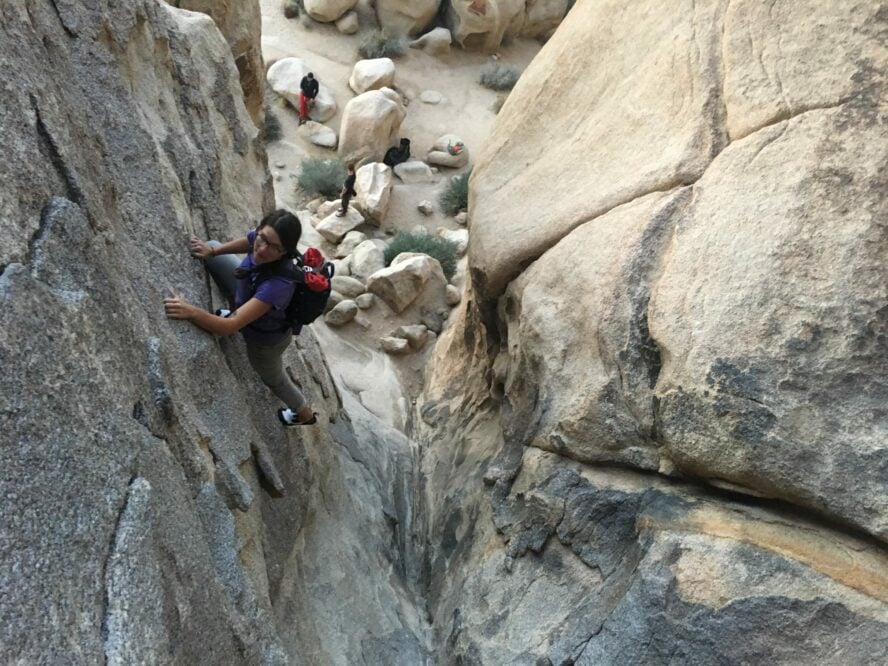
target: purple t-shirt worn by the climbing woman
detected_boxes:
[234,230,296,345]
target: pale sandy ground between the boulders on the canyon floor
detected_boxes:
[260,0,540,429]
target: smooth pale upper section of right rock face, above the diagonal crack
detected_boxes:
[471,2,876,294]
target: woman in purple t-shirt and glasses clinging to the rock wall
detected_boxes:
[163,210,317,426]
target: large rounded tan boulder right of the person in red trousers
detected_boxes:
[339,88,407,162]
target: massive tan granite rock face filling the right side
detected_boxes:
[416,1,888,665]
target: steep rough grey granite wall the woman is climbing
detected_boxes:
[0,0,426,664]
